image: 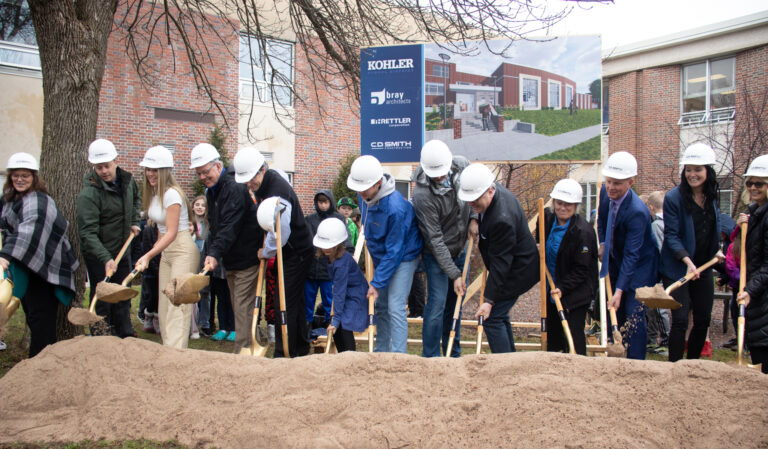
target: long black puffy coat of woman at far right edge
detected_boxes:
[742,203,768,347]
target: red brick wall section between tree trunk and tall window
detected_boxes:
[97,3,239,193]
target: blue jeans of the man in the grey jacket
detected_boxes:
[421,251,466,357]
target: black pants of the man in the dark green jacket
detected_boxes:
[85,257,133,338]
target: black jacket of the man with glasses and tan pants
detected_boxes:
[205,167,264,270]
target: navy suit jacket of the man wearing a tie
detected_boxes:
[597,186,666,292]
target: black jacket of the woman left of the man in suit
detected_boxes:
[536,208,599,310]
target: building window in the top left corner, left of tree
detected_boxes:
[0,0,40,70]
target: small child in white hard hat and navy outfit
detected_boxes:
[312,218,368,352]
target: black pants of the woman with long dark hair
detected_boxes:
[662,268,715,362]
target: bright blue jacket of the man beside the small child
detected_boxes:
[358,174,422,288]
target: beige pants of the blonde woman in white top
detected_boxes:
[157,229,200,348]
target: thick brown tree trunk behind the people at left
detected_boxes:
[29,0,117,340]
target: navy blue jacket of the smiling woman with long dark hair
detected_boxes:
[659,186,720,279]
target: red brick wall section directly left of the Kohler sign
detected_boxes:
[293,38,360,214]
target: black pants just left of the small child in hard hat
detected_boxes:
[274,252,312,357]
